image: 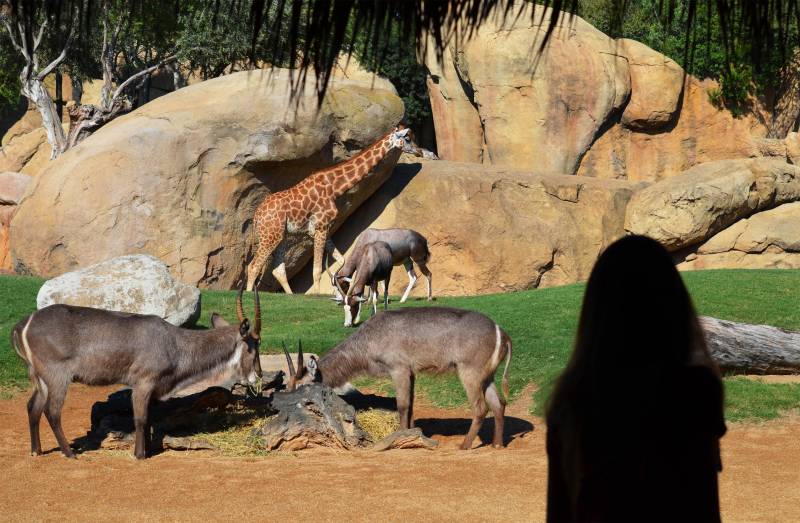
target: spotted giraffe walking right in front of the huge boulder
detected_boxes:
[247,126,417,294]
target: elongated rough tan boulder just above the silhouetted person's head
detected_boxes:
[625,158,800,250]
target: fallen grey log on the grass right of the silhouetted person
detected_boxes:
[700,316,800,374]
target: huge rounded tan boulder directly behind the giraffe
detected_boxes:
[11,65,403,288]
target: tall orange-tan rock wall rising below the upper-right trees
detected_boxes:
[425,2,788,181]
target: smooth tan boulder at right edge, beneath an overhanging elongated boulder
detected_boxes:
[678,201,800,269]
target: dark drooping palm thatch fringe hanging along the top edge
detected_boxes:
[6,0,800,101]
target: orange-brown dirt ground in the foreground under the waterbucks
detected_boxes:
[0,385,800,521]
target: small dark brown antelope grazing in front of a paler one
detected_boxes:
[325,242,394,327]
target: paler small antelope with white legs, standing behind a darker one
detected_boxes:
[331,229,433,303]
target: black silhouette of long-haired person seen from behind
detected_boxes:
[546,236,726,521]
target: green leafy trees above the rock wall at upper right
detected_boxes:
[578,0,800,126]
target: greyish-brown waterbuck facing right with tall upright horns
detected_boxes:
[11,290,261,459]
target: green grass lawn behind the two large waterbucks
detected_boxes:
[0,270,800,420]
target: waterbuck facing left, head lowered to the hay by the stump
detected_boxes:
[284,307,511,449]
